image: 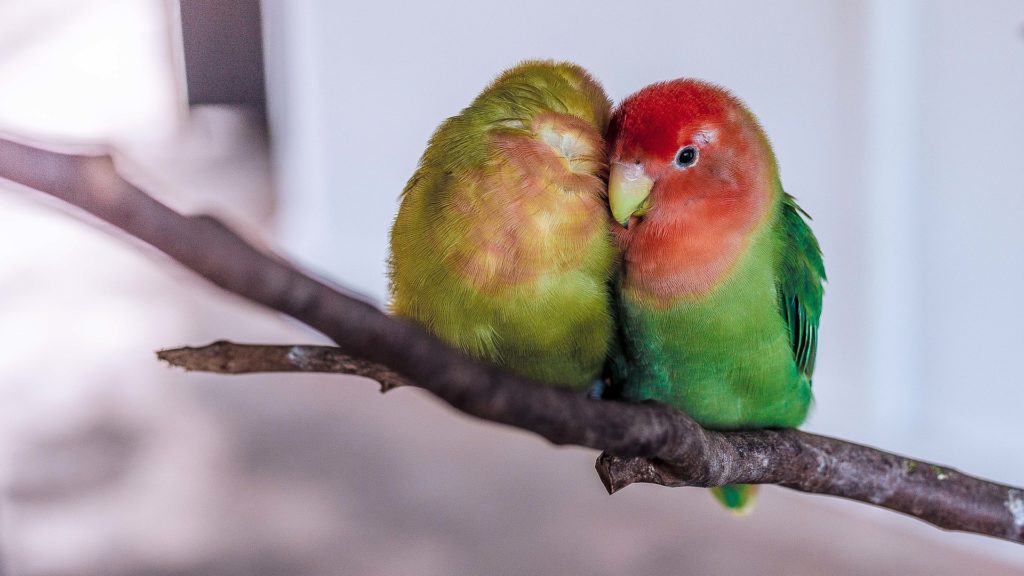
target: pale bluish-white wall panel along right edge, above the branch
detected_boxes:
[915,0,1024,473]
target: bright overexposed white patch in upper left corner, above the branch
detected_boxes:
[0,0,185,143]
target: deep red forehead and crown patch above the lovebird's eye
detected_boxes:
[608,79,736,158]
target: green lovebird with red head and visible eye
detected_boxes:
[608,79,825,512]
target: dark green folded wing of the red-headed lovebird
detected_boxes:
[778,193,825,381]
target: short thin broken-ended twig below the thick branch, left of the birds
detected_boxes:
[157,340,409,393]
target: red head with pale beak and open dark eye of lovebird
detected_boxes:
[608,79,775,234]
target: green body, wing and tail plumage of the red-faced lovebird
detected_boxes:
[614,179,825,506]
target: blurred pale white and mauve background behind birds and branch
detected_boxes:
[0,0,1024,575]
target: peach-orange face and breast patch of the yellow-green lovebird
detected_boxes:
[450,113,609,293]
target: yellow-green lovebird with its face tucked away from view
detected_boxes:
[389,61,616,390]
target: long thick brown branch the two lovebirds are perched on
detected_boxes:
[0,135,1024,542]
